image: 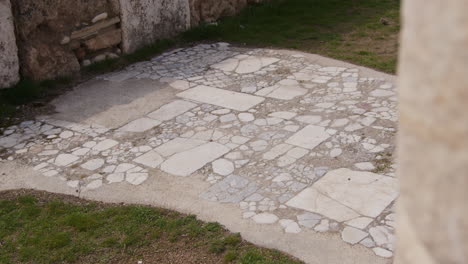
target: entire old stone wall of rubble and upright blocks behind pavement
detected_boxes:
[0,0,263,88]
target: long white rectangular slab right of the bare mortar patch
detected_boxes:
[177,85,265,111]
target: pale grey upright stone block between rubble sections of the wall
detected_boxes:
[120,0,190,53]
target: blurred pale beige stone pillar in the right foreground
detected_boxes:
[395,0,468,264]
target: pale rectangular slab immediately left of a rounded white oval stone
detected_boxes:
[161,142,230,177]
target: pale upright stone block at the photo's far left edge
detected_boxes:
[0,0,19,88]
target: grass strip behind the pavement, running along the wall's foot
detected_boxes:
[183,0,400,73]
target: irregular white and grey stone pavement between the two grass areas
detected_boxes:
[0,43,398,263]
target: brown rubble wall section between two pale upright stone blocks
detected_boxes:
[13,0,121,80]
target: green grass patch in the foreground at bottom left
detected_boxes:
[0,194,300,264]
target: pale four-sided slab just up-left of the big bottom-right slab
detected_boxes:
[286,125,330,149]
